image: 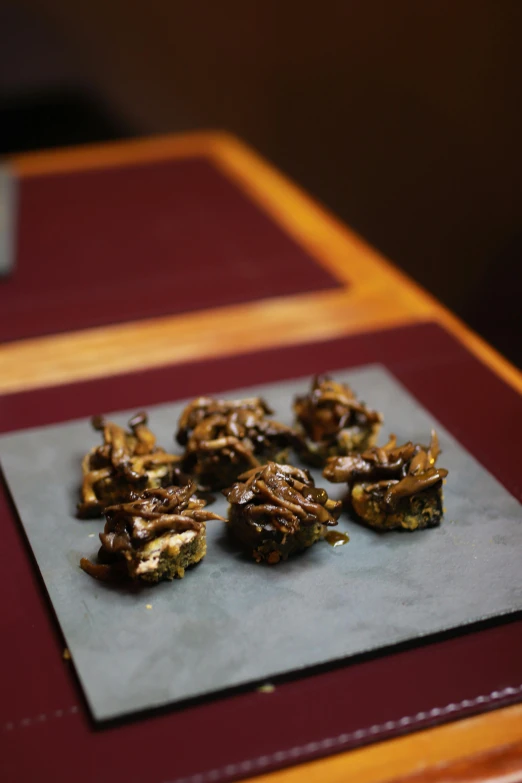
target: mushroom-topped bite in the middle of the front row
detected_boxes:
[223,462,342,563]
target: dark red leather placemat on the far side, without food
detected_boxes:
[0,158,341,341]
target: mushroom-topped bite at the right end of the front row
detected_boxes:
[323,430,448,530]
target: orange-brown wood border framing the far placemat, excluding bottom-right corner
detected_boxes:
[0,132,522,393]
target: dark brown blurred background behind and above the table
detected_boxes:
[0,0,522,364]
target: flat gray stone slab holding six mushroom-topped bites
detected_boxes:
[0,366,522,720]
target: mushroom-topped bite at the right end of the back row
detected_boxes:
[294,375,383,466]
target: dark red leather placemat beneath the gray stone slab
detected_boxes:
[0,324,522,783]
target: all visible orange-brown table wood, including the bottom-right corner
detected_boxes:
[0,133,522,783]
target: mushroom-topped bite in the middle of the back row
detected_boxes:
[176,397,296,490]
